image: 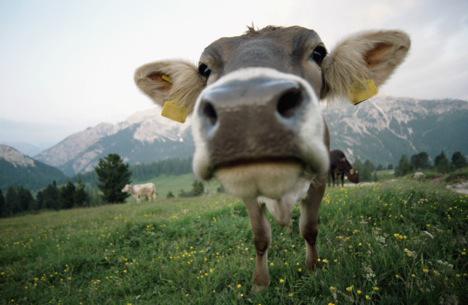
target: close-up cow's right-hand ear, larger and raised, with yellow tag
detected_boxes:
[322,31,411,104]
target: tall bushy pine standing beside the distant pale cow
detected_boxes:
[95,154,131,203]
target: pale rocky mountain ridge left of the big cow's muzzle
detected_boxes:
[35,108,194,175]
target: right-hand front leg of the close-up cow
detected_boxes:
[299,180,326,270]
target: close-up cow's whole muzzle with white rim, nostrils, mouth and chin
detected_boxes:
[193,68,329,196]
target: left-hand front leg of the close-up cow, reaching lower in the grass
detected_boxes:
[245,199,271,292]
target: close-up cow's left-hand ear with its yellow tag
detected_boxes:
[135,60,206,120]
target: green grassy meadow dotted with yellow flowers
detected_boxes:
[0,178,468,305]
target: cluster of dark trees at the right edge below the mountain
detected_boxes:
[395,151,468,177]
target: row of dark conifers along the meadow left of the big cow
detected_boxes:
[0,154,192,216]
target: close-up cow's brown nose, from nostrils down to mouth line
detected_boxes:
[196,77,313,167]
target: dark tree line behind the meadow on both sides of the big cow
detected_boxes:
[0,151,467,217]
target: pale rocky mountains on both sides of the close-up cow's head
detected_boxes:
[36,97,468,175]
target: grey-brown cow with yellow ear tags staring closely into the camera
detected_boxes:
[134,26,410,292]
